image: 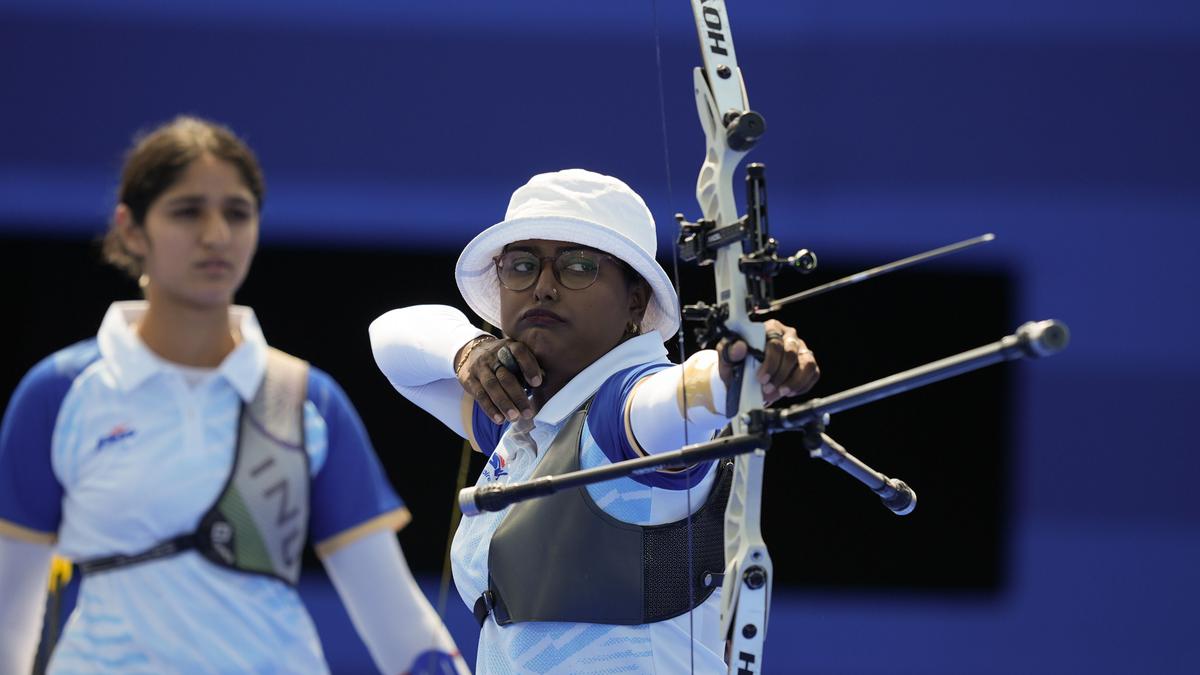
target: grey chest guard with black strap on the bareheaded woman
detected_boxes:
[78,348,311,585]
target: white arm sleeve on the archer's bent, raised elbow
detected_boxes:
[368,305,486,437]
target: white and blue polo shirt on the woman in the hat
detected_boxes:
[451,333,726,675]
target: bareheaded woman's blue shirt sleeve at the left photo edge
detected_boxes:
[0,350,87,543]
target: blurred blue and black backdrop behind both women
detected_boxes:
[0,0,1200,674]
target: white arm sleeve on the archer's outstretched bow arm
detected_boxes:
[625,350,728,454]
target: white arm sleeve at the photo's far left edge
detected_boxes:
[0,536,54,673]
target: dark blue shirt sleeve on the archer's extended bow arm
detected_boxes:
[588,363,713,490]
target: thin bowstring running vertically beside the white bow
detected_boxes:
[650,0,696,674]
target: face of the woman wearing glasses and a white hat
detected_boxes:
[500,239,649,375]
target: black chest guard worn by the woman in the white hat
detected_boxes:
[475,405,733,626]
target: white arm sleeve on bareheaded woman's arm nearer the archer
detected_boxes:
[322,530,470,675]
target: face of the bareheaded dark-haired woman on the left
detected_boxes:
[118,154,258,307]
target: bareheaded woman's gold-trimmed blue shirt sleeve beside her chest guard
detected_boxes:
[308,368,409,555]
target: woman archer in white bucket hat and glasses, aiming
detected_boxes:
[371,169,818,674]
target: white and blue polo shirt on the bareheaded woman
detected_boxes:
[0,301,408,674]
